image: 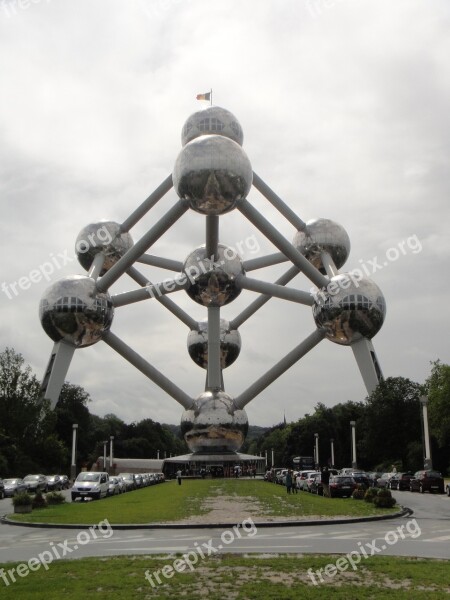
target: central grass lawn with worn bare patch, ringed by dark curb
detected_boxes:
[10,479,398,525]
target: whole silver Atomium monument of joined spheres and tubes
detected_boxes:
[40,106,386,468]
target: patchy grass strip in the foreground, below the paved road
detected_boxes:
[0,555,449,600]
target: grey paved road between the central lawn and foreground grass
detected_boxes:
[0,492,450,562]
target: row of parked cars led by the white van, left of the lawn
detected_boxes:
[70,471,165,502]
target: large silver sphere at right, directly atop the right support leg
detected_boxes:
[313,273,386,346]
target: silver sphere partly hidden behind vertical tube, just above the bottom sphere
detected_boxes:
[187,319,241,369]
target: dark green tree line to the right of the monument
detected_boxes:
[245,361,450,474]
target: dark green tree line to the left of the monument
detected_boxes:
[0,348,187,477]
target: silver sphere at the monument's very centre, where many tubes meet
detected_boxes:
[183,244,244,306]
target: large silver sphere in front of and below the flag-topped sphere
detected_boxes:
[172,135,253,215]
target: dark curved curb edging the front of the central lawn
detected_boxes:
[0,506,413,531]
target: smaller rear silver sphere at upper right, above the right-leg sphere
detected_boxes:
[292,219,350,273]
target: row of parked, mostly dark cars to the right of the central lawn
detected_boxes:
[265,468,450,498]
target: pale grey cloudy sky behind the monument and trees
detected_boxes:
[0,0,450,432]
